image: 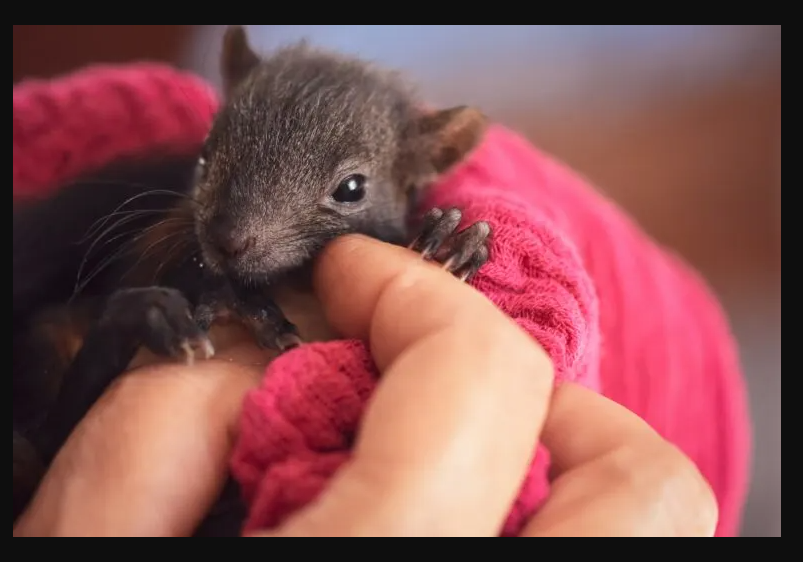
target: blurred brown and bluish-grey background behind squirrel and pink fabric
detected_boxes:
[13,25,781,537]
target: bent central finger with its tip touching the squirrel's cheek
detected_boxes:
[276,236,553,536]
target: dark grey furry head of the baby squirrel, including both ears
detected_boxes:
[195,26,485,284]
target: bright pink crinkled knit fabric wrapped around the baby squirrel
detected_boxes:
[13,61,750,536]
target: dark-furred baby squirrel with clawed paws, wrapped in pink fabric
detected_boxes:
[13,26,491,532]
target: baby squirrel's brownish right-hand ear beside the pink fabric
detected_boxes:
[418,106,488,174]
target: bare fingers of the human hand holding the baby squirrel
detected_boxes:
[13,236,717,537]
